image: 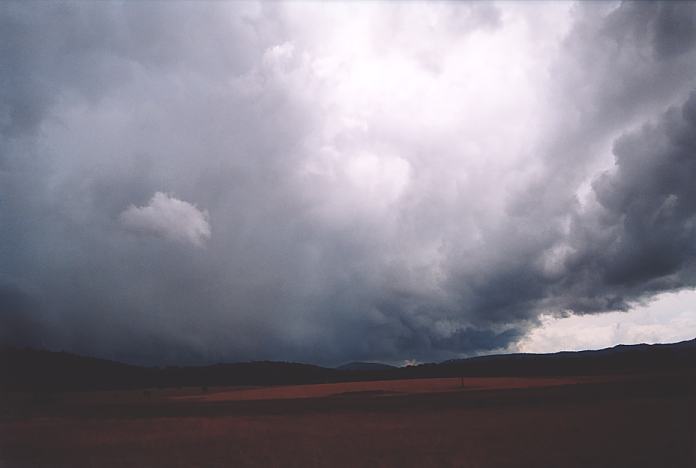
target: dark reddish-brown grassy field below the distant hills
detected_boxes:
[0,372,696,467]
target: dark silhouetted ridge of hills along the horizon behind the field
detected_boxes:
[0,339,696,391]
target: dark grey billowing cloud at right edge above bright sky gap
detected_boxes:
[568,93,696,311]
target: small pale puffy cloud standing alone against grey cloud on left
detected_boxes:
[119,192,210,247]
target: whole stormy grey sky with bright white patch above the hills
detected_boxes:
[0,1,696,365]
